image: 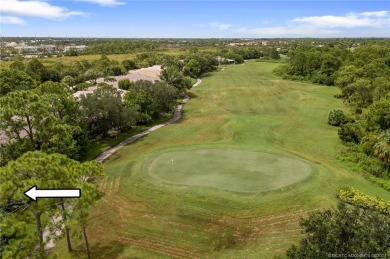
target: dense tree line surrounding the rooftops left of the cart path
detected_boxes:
[0,50,218,162]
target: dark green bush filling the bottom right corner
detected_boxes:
[286,201,390,259]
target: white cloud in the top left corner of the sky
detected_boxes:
[0,0,85,20]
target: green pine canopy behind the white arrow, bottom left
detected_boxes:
[0,151,103,258]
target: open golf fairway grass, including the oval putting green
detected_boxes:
[53,62,390,258]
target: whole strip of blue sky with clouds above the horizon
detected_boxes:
[0,0,390,38]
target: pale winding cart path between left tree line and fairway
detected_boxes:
[95,78,202,162]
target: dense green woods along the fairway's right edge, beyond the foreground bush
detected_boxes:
[275,42,390,190]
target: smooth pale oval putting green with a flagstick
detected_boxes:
[148,149,311,192]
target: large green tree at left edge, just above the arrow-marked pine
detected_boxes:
[0,90,82,163]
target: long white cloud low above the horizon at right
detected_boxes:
[237,11,390,38]
